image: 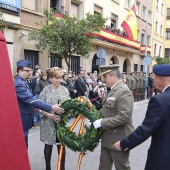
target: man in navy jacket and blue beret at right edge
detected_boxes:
[113,64,170,170]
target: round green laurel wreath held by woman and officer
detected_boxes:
[55,97,102,152]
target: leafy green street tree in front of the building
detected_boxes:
[29,10,105,70]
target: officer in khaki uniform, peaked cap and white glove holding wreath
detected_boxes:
[93,64,134,170]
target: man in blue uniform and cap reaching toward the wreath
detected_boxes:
[14,60,64,147]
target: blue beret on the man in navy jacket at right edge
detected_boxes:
[153,64,170,76]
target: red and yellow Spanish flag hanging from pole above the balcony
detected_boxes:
[121,4,137,40]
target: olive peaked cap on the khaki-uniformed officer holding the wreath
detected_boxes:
[99,64,120,75]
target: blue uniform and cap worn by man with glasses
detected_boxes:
[14,60,52,146]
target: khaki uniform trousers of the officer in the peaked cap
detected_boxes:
[99,146,130,170]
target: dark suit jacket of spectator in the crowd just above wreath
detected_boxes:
[75,77,87,97]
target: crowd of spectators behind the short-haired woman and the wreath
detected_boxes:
[27,65,108,113]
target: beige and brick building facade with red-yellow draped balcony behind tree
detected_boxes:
[0,0,153,72]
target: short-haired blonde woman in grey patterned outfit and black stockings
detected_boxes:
[40,67,69,170]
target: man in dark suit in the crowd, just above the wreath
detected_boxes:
[75,70,87,97]
